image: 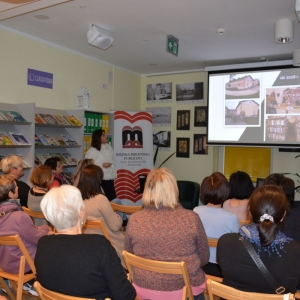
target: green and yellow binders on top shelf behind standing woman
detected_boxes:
[84,112,109,134]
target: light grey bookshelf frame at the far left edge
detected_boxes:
[0,103,35,184]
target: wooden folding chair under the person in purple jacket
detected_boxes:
[0,235,36,300]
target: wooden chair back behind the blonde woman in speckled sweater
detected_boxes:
[122,250,194,300]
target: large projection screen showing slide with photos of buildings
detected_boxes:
[208,67,300,147]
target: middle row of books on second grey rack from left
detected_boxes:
[34,134,78,146]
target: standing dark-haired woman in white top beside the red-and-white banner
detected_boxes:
[85,129,117,201]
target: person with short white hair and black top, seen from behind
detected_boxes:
[35,185,136,300]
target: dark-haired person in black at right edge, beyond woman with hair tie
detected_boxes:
[264,173,300,242]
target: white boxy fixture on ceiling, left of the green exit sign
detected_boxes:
[87,24,114,50]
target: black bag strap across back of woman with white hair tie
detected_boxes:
[241,238,285,295]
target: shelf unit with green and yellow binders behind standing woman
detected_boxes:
[70,109,114,156]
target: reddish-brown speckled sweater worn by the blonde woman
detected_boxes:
[125,205,209,291]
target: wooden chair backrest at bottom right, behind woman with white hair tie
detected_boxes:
[206,279,294,300]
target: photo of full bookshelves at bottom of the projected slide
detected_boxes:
[266,116,286,141]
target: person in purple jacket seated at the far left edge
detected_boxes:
[0,175,49,296]
